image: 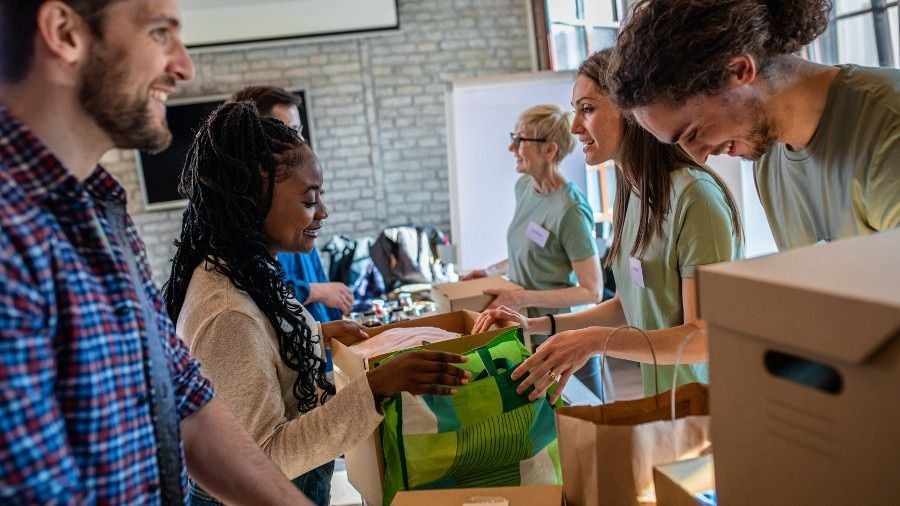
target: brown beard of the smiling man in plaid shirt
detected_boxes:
[79,44,172,153]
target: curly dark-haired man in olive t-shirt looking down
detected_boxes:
[609,0,900,250]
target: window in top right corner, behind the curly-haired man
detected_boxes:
[806,0,900,67]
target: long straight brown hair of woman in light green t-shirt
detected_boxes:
[578,49,743,267]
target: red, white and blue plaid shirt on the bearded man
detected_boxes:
[0,106,213,504]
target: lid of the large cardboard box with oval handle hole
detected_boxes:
[698,229,900,364]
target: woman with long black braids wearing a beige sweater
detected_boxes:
[164,102,468,505]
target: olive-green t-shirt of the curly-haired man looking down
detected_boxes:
[755,65,900,251]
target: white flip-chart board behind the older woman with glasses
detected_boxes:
[444,72,588,271]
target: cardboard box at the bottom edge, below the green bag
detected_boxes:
[392,485,563,506]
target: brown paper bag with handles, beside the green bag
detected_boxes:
[556,327,710,506]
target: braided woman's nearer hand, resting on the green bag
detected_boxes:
[366,350,472,405]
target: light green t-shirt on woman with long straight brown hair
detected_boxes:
[612,167,742,395]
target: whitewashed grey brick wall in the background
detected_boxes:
[102,0,532,285]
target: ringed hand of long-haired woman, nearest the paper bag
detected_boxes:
[512,327,605,403]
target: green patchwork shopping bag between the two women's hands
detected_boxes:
[381,328,562,504]
